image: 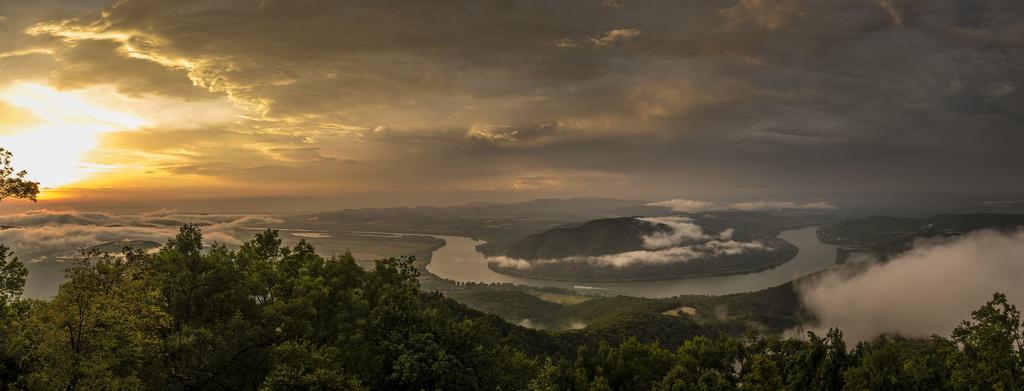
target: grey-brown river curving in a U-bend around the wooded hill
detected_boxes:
[427,227,836,298]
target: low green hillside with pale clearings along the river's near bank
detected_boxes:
[438,283,813,337]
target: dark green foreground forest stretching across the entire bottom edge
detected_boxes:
[0,225,1024,390]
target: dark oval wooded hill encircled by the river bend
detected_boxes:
[479,216,799,283]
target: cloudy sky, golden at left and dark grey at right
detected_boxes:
[0,0,1024,212]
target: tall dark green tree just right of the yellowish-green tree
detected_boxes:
[145,224,275,389]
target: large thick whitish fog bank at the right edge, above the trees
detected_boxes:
[798,231,1024,341]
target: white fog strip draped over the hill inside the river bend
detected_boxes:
[487,217,771,269]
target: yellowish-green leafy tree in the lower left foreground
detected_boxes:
[17,248,169,390]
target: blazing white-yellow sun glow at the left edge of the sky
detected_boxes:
[0,83,146,192]
